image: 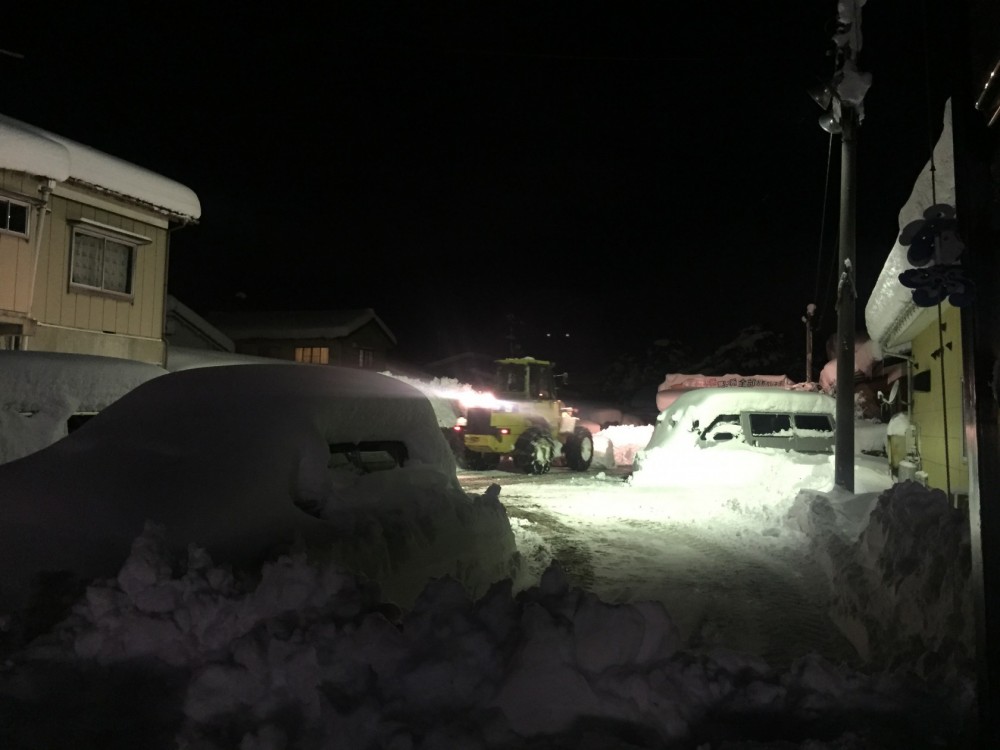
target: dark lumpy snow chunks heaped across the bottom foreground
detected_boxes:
[0,527,965,750]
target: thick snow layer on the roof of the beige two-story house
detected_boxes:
[0,114,201,220]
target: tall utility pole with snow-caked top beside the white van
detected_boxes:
[810,0,871,492]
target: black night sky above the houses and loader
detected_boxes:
[0,0,950,372]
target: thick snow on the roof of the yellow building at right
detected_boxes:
[865,99,955,351]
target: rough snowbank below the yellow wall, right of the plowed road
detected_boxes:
[790,481,975,682]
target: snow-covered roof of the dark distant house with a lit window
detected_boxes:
[208,307,396,344]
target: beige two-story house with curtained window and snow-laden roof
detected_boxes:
[0,115,201,365]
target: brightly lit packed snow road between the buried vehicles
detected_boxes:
[459,468,856,666]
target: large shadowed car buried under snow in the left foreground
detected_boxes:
[0,364,516,624]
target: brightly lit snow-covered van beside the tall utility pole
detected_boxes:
[630,388,887,490]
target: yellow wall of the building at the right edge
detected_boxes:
[911,303,969,502]
